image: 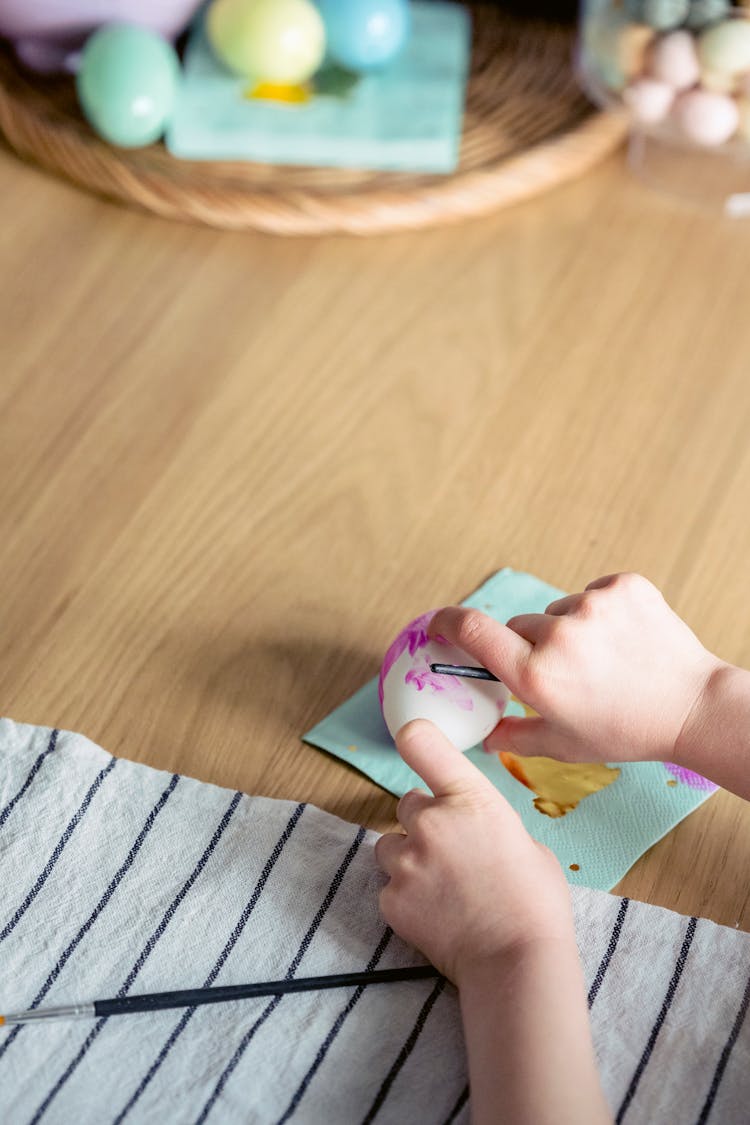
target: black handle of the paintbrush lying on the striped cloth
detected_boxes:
[93,965,440,1016]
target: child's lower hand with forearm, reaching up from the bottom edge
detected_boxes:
[376,719,612,1125]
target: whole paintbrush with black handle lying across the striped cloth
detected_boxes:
[0,965,440,1027]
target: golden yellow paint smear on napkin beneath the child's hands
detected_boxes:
[499,750,620,818]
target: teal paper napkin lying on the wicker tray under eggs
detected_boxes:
[165,0,471,172]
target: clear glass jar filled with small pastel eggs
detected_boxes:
[578,0,750,215]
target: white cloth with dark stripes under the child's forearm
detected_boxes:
[0,720,750,1125]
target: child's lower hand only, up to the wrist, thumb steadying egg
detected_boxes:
[376,719,573,986]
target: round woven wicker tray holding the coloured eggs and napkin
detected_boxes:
[0,5,625,234]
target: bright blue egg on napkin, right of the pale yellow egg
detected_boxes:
[317,0,412,71]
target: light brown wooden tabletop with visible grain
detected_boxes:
[0,153,750,929]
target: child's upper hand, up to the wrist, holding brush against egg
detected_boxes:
[430,574,724,762]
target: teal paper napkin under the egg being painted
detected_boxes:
[304,569,715,891]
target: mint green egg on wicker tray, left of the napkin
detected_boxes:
[76,24,180,149]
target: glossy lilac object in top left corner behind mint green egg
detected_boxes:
[0,0,200,73]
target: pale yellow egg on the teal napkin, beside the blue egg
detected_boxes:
[206,0,325,86]
